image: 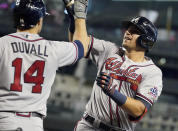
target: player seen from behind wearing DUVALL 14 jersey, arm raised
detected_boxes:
[0,0,88,131]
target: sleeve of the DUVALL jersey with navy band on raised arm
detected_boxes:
[49,40,84,67]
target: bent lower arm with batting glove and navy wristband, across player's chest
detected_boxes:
[96,72,145,117]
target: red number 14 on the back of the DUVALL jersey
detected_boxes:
[10,58,45,93]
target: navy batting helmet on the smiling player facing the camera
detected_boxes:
[122,16,158,51]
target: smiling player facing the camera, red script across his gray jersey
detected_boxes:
[64,0,162,131]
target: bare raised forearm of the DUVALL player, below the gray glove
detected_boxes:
[73,19,90,56]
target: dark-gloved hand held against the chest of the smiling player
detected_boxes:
[96,72,115,95]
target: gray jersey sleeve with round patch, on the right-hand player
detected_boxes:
[136,68,162,109]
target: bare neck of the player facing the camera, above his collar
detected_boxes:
[126,51,146,62]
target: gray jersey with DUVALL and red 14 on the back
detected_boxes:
[0,32,84,115]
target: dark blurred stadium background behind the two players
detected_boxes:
[0,0,178,131]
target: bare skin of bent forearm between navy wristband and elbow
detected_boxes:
[121,97,145,117]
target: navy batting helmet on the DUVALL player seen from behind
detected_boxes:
[13,0,48,30]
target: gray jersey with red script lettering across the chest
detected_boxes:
[77,38,162,131]
